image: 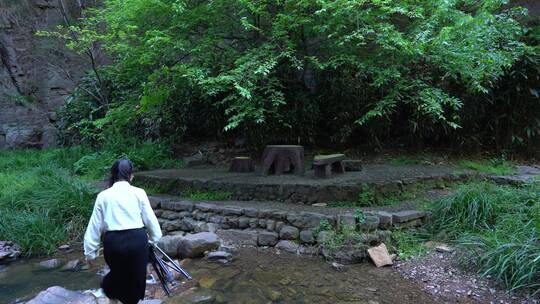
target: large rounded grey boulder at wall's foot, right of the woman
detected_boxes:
[178,232,220,258]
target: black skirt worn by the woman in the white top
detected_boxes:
[101,228,149,304]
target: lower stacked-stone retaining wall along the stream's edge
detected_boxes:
[151,198,430,246]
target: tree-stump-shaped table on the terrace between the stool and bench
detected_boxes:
[262,145,304,175]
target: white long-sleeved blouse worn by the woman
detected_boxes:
[84,181,162,260]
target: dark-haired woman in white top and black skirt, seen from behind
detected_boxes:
[84,159,162,304]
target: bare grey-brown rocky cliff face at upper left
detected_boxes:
[0,0,85,149]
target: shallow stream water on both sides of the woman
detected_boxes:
[0,250,437,304]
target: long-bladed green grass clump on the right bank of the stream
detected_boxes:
[433,183,540,294]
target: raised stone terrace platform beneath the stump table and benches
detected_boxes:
[136,164,471,204]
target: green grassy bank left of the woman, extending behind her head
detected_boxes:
[0,142,179,255]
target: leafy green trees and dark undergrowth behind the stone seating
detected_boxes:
[49,0,540,148]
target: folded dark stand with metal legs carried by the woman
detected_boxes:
[150,244,192,296]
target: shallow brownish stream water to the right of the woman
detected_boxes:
[166,250,437,304]
